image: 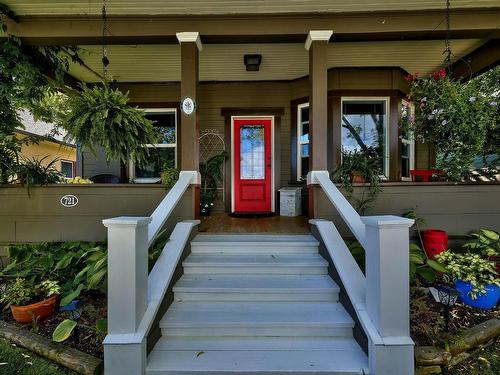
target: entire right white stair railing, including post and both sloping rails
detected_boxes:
[308,171,414,375]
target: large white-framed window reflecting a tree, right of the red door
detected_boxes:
[342,98,389,177]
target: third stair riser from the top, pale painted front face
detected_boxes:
[175,291,339,302]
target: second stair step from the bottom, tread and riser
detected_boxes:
[160,302,354,337]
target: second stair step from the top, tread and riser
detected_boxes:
[183,253,328,275]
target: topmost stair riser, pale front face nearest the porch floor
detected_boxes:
[191,243,318,254]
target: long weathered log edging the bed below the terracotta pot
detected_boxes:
[0,322,103,375]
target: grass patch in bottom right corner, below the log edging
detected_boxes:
[448,340,500,375]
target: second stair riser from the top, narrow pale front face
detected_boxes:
[184,265,328,275]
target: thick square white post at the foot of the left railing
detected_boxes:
[103,217,151,375]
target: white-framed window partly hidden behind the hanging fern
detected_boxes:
[131,108,177,183]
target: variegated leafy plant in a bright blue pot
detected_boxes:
[436,250,500,309]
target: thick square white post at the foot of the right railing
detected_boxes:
[362,216,414,375]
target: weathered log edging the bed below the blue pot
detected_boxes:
[450,318,500,356]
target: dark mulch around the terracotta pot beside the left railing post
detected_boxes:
[0,293,106,358]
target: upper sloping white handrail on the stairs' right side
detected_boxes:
[311,171,366,247]
